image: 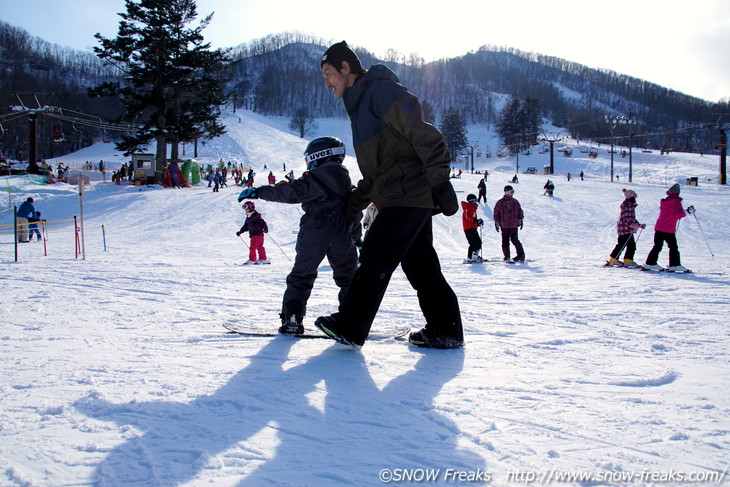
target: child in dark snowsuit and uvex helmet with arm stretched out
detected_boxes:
[239,137,357,334]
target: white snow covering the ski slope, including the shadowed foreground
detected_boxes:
[0,112,730,486]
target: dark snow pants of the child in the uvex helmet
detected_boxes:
[282,212,357,318]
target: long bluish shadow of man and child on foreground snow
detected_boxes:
[75,337,484,486]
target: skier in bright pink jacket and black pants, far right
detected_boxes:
[644,184,695,272]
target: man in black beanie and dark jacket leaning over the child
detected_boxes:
[315,41,464,348]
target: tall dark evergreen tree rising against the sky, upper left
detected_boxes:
[90,0,229,167]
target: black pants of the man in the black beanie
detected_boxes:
[335,207,464,342]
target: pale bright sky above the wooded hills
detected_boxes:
[0,0,730,101]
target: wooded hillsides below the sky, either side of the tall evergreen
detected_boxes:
[0,21,729,164]
